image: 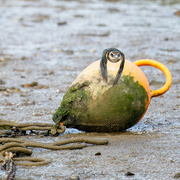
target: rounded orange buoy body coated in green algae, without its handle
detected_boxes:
[53,60,151,132]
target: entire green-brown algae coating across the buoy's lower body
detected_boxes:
[53,75,149,132]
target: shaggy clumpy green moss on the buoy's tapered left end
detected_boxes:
[53,81,92,128]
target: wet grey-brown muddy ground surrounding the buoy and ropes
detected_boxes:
[0,0,180,180]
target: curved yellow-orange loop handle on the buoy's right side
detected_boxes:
[134,59,172,97]
